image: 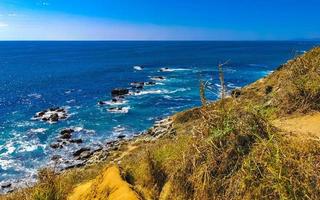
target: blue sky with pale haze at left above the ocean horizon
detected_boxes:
[0,0,320,40]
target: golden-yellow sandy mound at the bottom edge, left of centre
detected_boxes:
[68,166,140,200]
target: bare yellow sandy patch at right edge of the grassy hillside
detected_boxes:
[274,113,320,137]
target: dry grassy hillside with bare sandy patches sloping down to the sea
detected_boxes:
[0,48,320,200]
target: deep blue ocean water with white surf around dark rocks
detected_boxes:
[0,42,319,188]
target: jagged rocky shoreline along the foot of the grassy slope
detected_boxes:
[0,117,175,194]
